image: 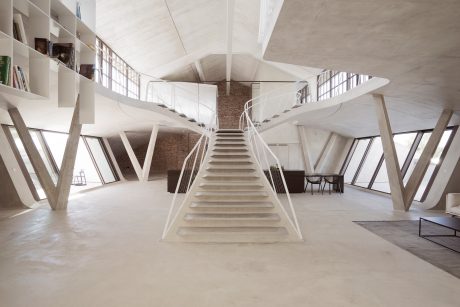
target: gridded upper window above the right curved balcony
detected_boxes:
[318,70,371,101]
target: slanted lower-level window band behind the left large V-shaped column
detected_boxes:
[5,126,118,200]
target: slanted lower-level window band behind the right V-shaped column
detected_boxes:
[344,128,455,201]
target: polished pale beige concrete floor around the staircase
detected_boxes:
[0,180,460,307]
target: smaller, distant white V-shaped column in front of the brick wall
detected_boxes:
[120,125,158,181]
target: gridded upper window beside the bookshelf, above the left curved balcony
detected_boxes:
[96,38,140,99]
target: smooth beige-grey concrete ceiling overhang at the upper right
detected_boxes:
[264,0,460,135]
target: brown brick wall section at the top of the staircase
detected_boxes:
[217,82,252,129]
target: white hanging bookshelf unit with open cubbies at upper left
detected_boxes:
[0,0,96,124]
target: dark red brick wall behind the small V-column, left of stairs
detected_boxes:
[108,131,200,179]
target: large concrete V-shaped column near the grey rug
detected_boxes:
[373,95,453,211]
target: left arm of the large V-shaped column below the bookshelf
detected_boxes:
[8,108,56,209]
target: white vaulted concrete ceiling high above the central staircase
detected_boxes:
[96,0,318,82]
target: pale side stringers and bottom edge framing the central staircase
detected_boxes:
[163,133,302,243]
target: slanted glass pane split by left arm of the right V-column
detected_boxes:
[372,133,417,193]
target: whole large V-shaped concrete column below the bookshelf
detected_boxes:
[8,97,82,210]
